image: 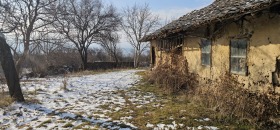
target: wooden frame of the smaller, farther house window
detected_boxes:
[200,39,212,67]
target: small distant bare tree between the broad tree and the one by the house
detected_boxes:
[99,33,121,63]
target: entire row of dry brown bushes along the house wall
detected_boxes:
[149,50,280,129]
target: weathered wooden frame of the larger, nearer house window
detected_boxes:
[229,39,249,76]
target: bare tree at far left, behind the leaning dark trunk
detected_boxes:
[0,0,56,72]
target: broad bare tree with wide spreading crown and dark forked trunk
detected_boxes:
[51,0,120,69]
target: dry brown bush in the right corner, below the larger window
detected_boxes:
[194,73,280,128]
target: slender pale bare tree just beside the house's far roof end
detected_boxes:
[122,4,159,67]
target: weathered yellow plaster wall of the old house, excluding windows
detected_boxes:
[152,10,280,92]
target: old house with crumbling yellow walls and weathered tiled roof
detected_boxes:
[141,0,280,92]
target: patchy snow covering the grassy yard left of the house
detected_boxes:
[0,70,219,130]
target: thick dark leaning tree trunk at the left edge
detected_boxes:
[0,34,24,102]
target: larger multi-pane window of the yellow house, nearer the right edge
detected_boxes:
[230,39,247,75]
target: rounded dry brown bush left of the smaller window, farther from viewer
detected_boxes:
[150,50,198,93]
